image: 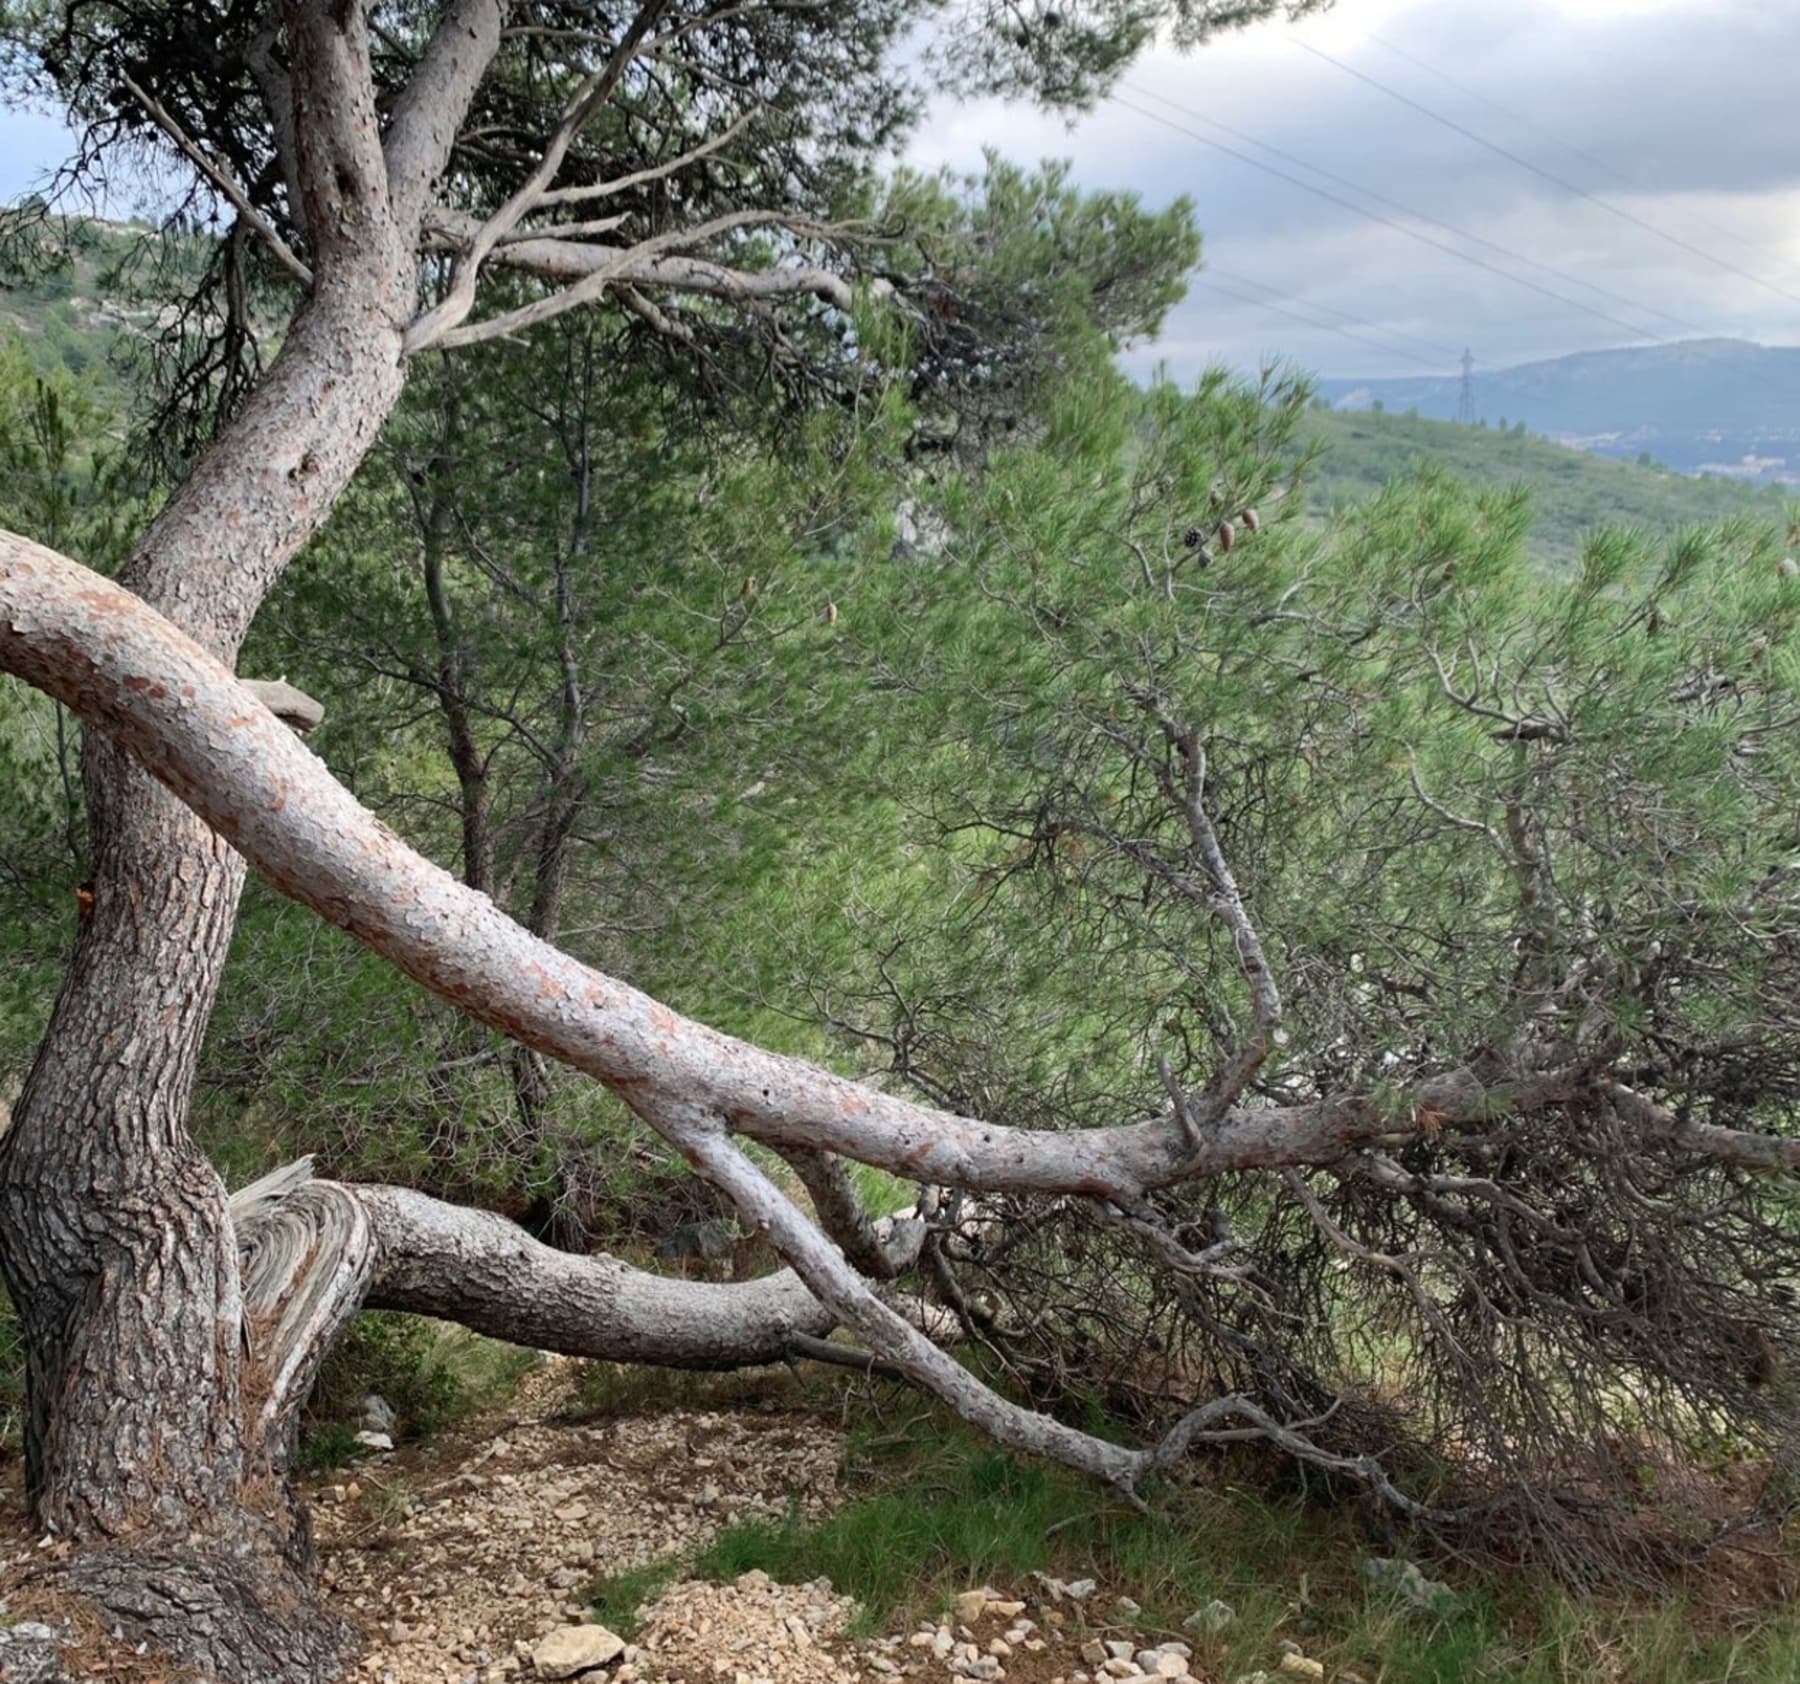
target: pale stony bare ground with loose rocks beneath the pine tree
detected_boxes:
[0,1364,1361,1684]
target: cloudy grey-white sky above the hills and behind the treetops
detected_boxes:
[0,0,1800,378]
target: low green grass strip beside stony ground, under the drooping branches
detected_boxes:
[680,1414,1800,1684]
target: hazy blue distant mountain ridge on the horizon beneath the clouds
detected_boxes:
[1319,338,1800,484]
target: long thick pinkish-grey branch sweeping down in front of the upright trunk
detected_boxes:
[0,536,1800,1198]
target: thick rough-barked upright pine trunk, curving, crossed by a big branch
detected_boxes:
[0,5,416,1679]
